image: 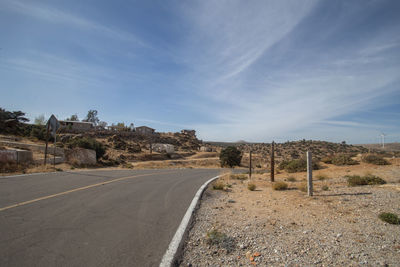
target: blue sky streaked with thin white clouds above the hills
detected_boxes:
[0,0,400,143]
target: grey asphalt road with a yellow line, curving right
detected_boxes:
[0,169,220,266]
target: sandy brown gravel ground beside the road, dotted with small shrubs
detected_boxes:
[181,165,400,266]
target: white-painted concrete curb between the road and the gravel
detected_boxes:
[160,175,221,267]
